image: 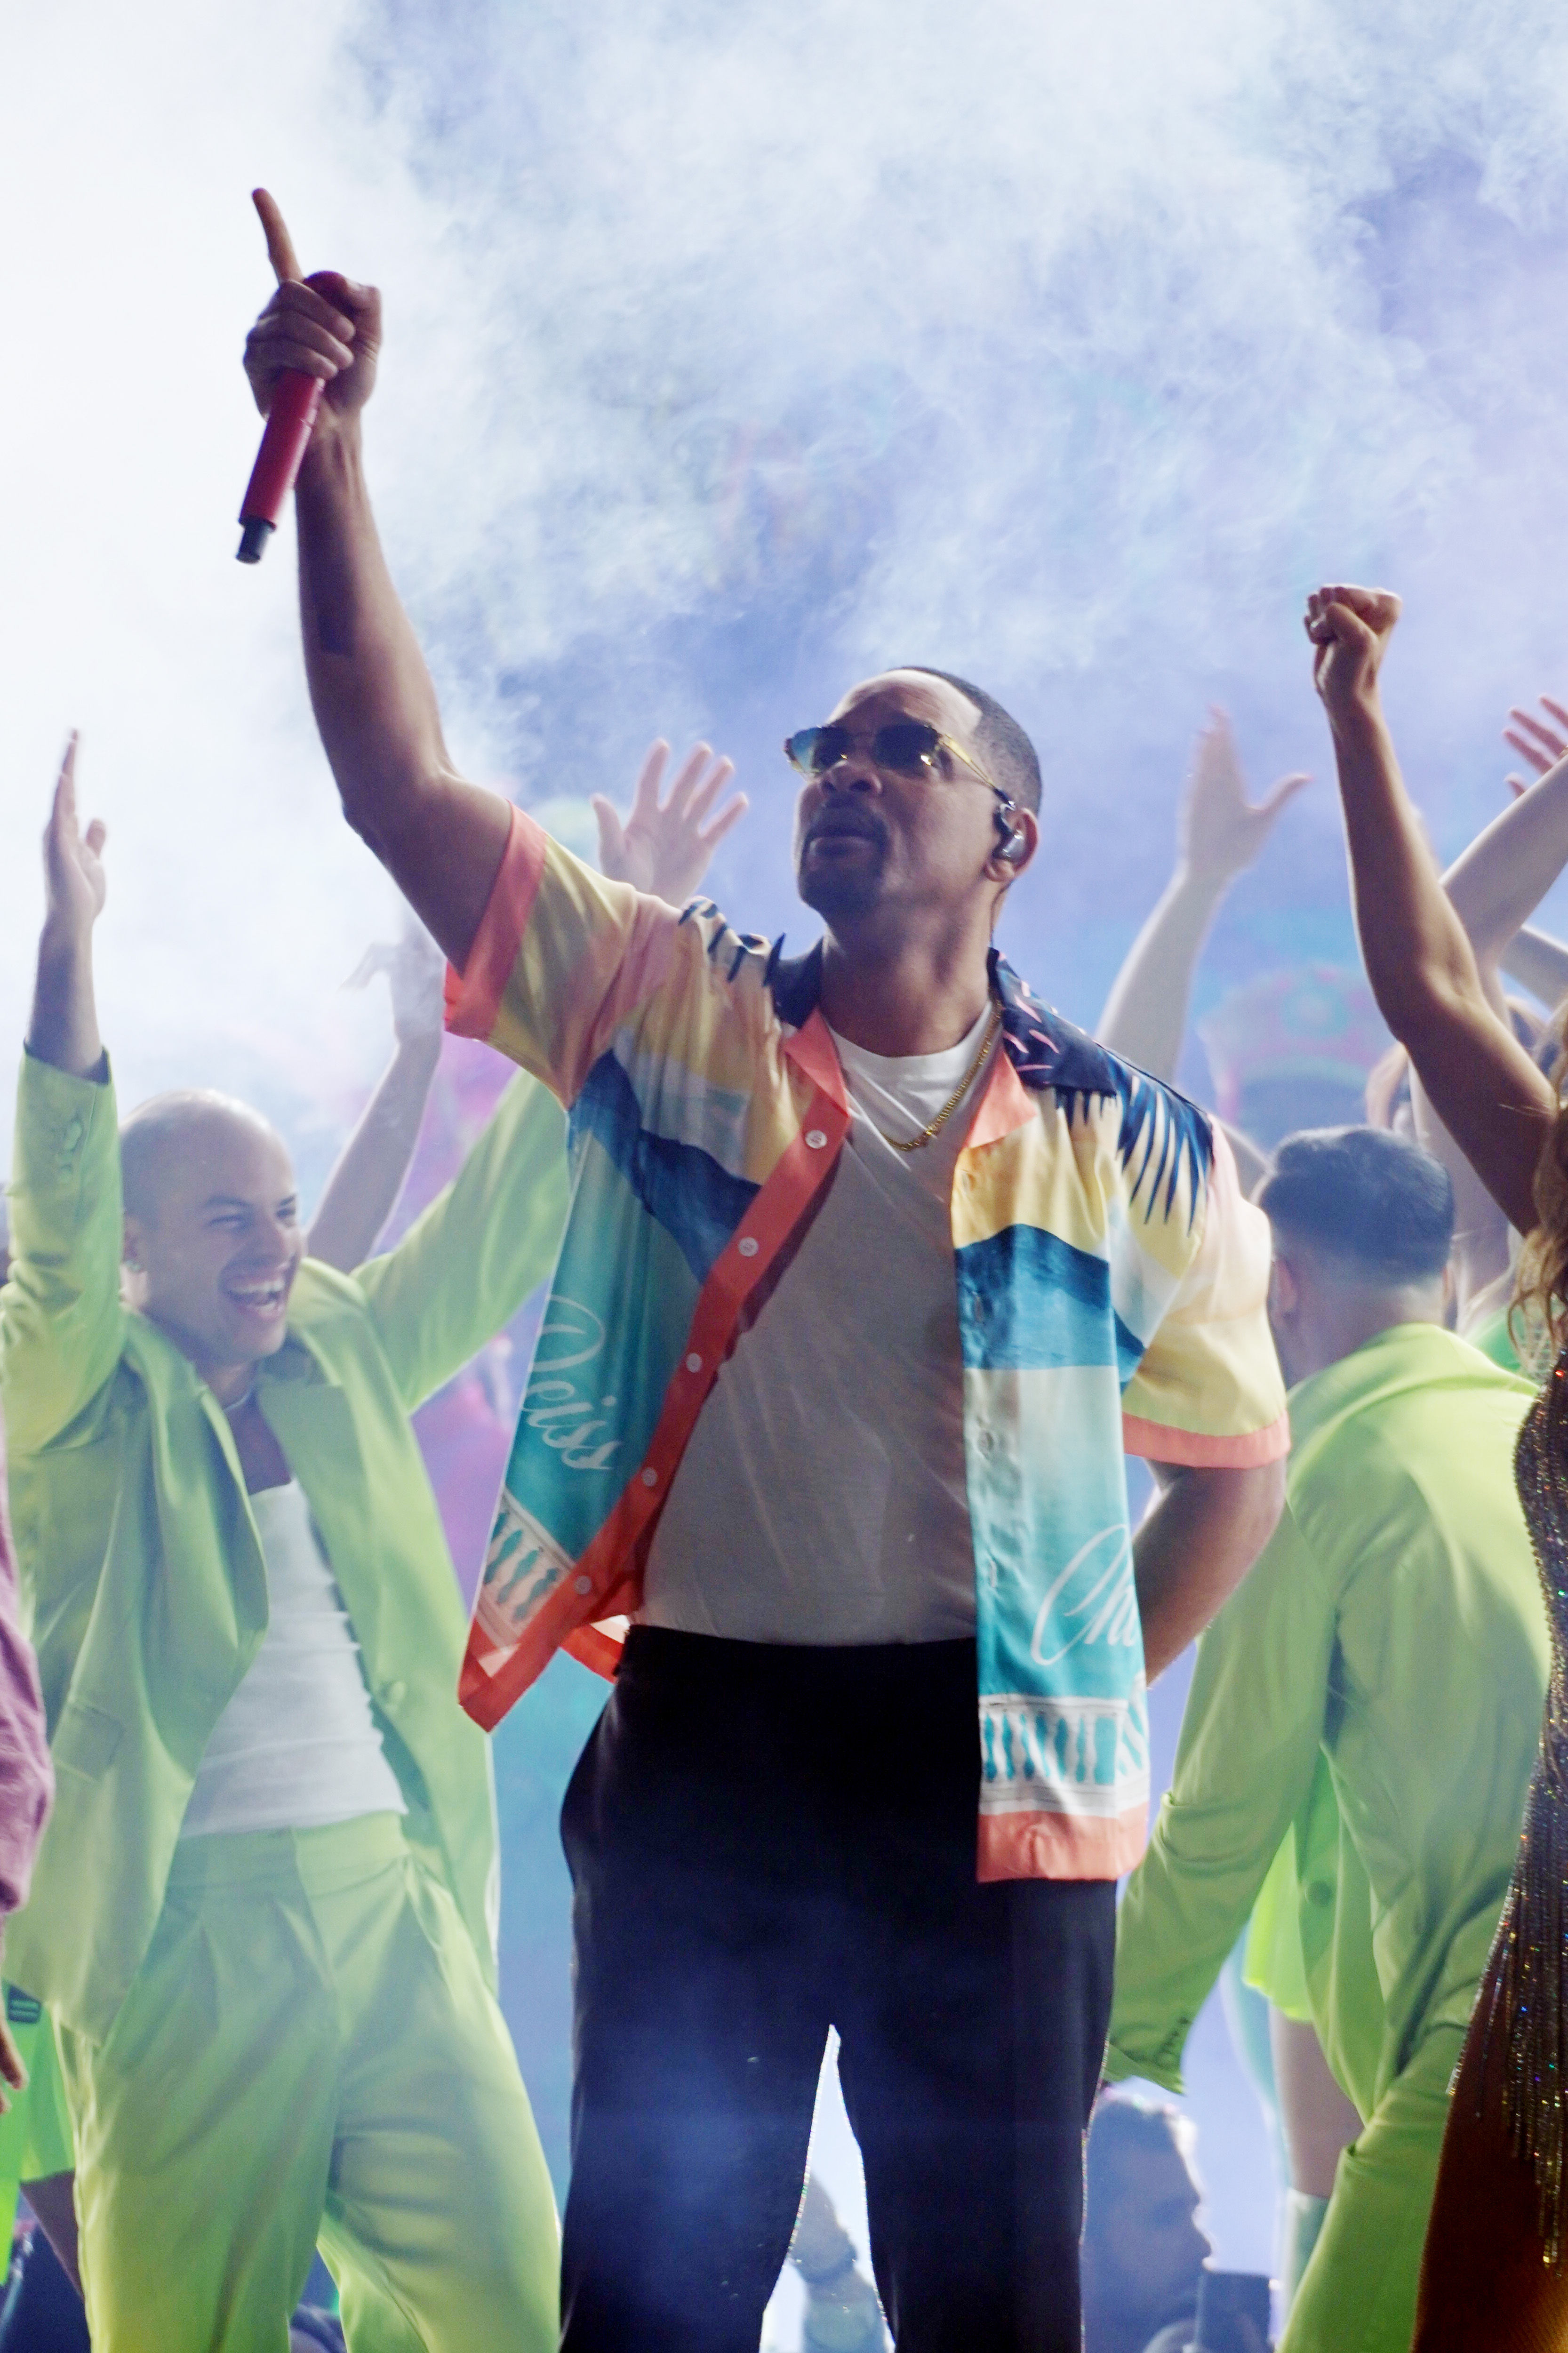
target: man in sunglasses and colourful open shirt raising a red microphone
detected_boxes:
[247,193,1286,2353]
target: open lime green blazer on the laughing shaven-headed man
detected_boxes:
[0,1056,565,2040]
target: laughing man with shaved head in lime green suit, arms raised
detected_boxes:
[0,755,565,2353]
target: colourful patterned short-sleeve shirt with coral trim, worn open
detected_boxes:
[448,812,1290,1878]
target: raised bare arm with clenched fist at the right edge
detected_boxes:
[1307,586,1556,1233]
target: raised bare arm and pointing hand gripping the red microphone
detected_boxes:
[245,191,511,972]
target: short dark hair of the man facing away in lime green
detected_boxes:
[1257,1127,1453,1282]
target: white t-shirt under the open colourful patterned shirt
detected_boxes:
[638,1005,991,1645]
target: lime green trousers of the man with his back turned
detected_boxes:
[1279,2026,1464,2353]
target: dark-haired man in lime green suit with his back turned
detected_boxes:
[1106,1127,1547,2353]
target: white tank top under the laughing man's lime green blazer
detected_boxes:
[179,1480,408,1838]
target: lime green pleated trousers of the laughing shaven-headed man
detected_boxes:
[59,1814,558,2353]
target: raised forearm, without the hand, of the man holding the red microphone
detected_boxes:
[296,419,509,969]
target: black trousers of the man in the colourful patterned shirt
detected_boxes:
[563,1628,1116,2353]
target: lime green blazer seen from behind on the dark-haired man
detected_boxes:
[1106,1325,1549,2115]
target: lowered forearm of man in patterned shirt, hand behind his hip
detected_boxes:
[1132,1464,1286,1682]
